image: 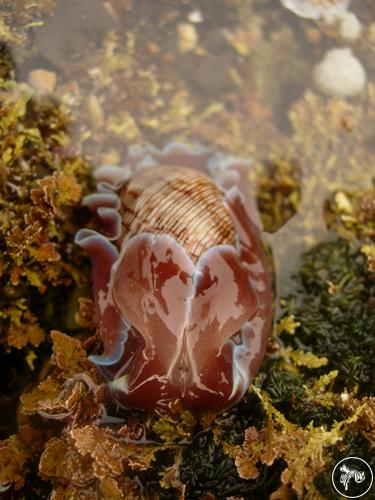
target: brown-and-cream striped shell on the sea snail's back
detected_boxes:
[120,167,236,262]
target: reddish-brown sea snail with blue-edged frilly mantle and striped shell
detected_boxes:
[76,143,272,412]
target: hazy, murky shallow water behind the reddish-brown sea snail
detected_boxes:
[0,0,375,496]
